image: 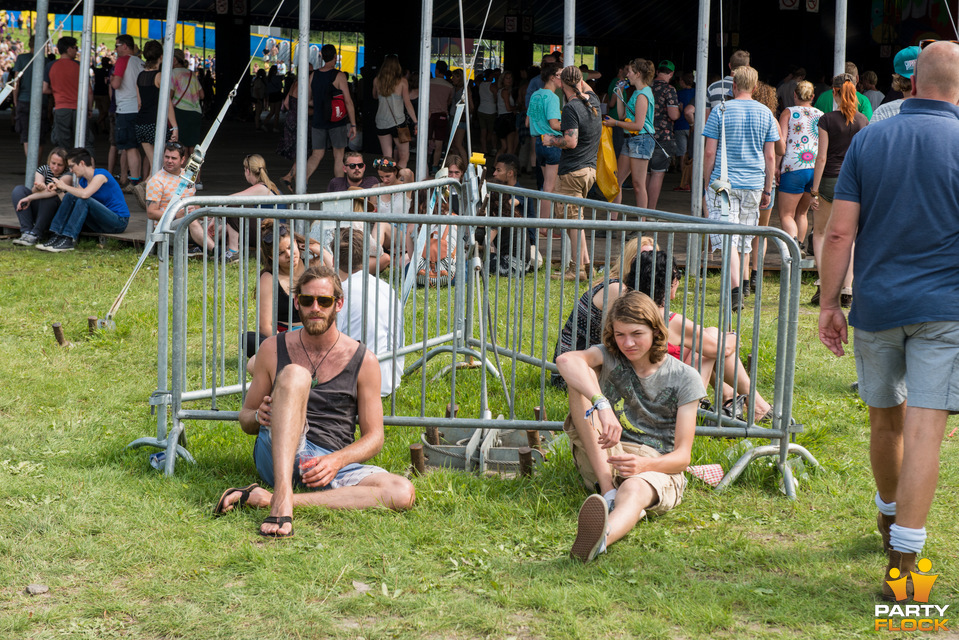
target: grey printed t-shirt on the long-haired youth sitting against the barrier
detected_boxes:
[597,345,706,454]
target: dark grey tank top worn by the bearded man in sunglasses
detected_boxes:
[274,336,366,451]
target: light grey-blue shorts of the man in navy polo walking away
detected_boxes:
[854,321,959,411]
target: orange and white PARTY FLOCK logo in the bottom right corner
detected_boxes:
[875,558,949,631]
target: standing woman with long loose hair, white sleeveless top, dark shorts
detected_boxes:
[373,54,417,169]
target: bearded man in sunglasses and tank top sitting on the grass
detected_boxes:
[214,265,416,538]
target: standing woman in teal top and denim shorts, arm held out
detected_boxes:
[603,58,656,209]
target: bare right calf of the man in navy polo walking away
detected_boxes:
[896,407,949,529]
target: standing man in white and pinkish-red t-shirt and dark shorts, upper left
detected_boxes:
[110,33,143,188]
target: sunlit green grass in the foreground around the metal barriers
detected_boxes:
[0,240,959,640]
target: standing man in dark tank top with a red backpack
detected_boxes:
[306,44,356,182]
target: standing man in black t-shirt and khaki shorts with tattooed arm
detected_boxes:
[543,66,603,280]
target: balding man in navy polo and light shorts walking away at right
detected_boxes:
[819,42,959,600]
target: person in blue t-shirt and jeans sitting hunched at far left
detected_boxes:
[36,148,130,253]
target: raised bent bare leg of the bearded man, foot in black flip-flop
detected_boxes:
[260,364,312,535]
